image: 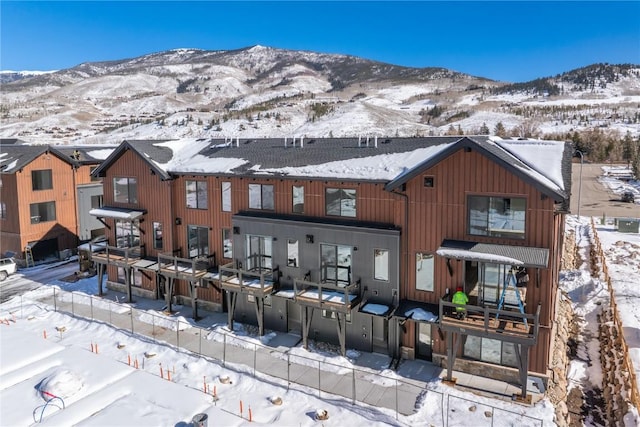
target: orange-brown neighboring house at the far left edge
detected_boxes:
[0,139,113,262]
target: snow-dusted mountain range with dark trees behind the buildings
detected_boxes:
[0,46,640,144]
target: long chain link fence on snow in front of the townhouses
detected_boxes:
[15,288,543,427]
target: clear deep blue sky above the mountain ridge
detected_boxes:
[0,0,640,82]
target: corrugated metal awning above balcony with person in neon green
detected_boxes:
[436,240,549,268]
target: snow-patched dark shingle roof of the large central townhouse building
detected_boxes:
[94,136,572,202]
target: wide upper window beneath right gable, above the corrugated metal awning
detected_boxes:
[468,196,526,239]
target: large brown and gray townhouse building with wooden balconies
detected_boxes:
[91,136,572,394]
